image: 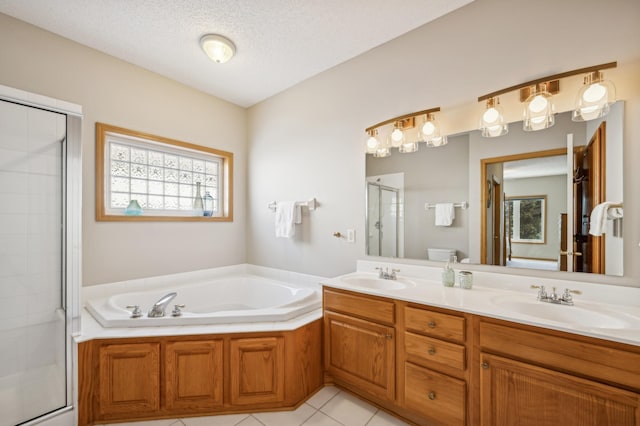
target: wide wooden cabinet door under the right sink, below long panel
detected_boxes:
[480,353,640,426]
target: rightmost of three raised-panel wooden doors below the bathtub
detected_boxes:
[229,337,285,405]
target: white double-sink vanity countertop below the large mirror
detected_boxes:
[322,261,640,346]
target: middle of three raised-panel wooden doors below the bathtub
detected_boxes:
[165,340,224,411]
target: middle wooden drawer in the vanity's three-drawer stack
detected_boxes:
[404,332,465,370]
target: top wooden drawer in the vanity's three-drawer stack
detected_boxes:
[404,306,464,343]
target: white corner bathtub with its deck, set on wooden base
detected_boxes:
[75,265,324,342]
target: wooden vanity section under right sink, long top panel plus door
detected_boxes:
[478,319,640,426]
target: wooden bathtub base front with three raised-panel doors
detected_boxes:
[78,320,322,426]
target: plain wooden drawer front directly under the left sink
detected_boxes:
[324,288,396,324]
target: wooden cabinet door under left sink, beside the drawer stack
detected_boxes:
[324,312,395,401]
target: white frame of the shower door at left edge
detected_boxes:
[0,85,82,426]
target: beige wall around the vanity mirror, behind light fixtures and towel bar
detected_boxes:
[248,0,640,284]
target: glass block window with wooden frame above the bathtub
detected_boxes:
[96,123,232,220]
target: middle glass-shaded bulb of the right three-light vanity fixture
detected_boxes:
[520,80,560,132]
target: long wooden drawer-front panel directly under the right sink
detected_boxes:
[480,321,640,391]
